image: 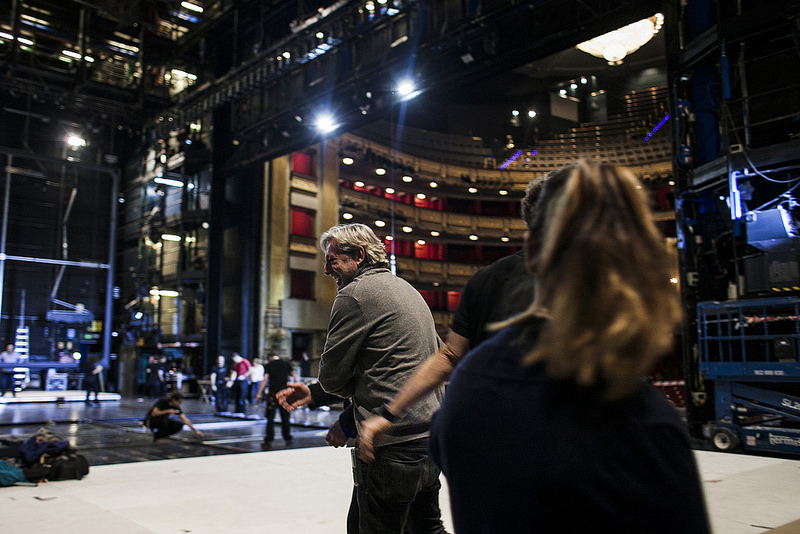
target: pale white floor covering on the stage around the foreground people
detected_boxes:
[0,448,800,534]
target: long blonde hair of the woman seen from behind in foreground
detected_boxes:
[507,161,681,398]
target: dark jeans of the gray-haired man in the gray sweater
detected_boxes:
[356,438,445,534]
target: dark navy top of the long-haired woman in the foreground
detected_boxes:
[431,322,710,534]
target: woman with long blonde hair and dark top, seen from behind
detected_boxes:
[431,162,710,534]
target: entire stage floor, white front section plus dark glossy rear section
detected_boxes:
[0,399,800,534]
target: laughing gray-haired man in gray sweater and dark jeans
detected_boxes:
[284,224,445,534]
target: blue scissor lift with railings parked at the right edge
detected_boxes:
[697,297,800,455]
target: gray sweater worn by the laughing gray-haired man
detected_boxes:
[319,267,443,445]
